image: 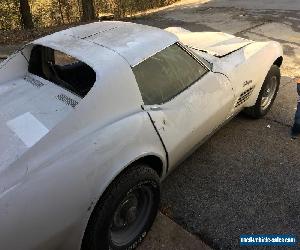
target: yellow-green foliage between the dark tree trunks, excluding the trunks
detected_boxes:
[0,0,178,30]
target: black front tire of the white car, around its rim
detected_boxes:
[244,65,280,119]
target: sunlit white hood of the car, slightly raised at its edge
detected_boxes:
[166,27,253,57]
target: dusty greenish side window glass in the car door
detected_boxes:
[133,44,207,105]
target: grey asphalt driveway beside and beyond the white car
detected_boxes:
[136,0,300,249]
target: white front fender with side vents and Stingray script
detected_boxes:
[215,41,283,107]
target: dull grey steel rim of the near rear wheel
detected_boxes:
[109,185,154,246]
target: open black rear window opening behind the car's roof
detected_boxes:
[28,45,96,97]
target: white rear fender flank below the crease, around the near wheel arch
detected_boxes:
[0,111,166,250]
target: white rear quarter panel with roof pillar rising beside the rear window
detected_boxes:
[0,40,166,250]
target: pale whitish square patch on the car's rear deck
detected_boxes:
[6,112,49,148]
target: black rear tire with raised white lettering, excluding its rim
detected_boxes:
[82,166,160,250]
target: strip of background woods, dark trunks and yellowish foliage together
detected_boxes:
[0,0,178,30]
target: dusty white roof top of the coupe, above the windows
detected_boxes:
[35,21,178,66]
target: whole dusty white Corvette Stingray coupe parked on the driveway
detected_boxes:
[0,22,283,250]
